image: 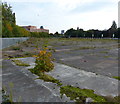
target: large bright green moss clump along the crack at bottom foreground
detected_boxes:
[60,86,106,103]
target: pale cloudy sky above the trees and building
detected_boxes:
[3,0,119,33]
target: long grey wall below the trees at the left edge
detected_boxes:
[0,37,29,49]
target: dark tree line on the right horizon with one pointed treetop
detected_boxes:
[64,21,120,38]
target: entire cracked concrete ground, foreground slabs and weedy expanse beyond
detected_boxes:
[3,38,120,102]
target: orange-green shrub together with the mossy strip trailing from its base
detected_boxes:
[29,44,62,86]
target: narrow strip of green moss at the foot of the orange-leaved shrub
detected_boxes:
[28,69,62,86]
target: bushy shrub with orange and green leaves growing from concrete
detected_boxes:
[34,47,54,73]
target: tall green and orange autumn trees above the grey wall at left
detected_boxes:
[2,3,31,37]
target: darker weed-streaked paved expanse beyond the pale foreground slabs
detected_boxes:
[3,38,120,77]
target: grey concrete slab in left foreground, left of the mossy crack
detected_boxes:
[2,58,71,102]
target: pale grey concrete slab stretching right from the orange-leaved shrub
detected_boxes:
[48,63,119,96]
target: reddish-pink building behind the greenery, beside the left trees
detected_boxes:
[22,26,49,33]
